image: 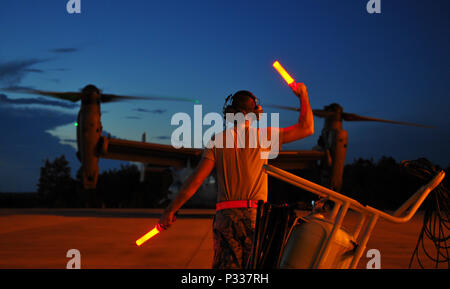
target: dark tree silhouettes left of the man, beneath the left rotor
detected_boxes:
[0,155,172,208]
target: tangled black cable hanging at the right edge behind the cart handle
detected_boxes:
[403,158,450,269]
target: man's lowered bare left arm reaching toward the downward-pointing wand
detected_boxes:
[159,158,215,228]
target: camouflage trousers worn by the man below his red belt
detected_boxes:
[212,208,257,269]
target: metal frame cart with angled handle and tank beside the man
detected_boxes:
[248,165,445,269]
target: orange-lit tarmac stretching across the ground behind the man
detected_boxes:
[0,209,442,269]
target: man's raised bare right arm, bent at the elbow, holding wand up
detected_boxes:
[280,82,314,144]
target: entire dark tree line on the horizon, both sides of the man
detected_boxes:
[0,155,449,210]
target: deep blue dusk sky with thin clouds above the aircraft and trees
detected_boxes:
[0,0,450,192]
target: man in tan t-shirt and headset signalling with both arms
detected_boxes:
[159,82,314,269]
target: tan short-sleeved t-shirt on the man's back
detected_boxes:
[203,127,281,202]
